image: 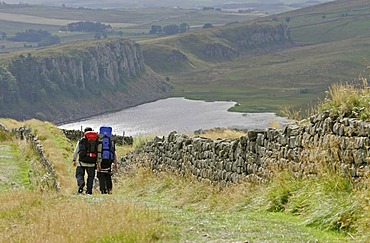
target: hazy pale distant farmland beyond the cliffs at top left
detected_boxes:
[0,4,265,52]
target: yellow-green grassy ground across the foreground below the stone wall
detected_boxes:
[0,119,369,242]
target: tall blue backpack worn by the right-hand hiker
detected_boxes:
[99,126,115,169]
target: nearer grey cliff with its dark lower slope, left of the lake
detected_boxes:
[0,39,171,123]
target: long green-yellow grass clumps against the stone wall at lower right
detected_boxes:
[248,128,370,241]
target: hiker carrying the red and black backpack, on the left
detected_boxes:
[73,127,98,194]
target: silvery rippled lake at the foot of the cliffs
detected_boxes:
[60,98,289,136]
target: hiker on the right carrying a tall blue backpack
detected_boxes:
[97,126,118,194]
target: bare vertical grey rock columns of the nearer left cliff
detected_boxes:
[36,41,144,87]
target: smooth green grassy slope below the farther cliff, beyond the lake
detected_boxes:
[149,34,370,112]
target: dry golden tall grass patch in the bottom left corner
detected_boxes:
[0,191,170,242]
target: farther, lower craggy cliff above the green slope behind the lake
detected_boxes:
[144,21,292,73]
